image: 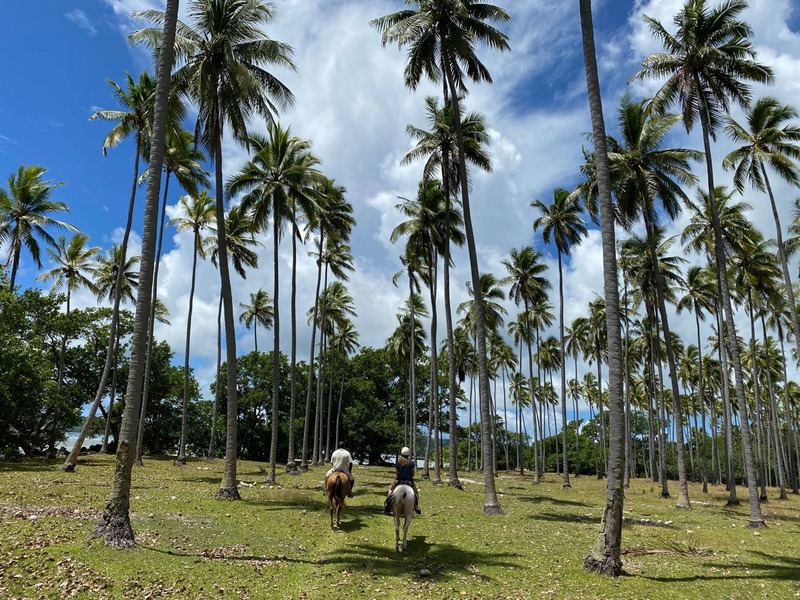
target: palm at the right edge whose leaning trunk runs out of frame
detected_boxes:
[722,97,800,398]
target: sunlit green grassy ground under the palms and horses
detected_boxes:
[0,455,800,600]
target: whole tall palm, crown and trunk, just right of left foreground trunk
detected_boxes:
[129,0,294,500]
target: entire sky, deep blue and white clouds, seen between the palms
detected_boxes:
[0,0,800,426]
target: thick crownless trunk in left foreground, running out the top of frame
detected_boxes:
[95,0,179,548]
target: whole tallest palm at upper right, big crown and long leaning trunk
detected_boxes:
[634,0,772,527]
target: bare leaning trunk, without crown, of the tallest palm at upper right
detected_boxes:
[695,91,766,527]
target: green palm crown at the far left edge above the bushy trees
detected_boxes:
[0,165,72,290]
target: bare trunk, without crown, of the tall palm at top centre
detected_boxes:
[444,68,503,515]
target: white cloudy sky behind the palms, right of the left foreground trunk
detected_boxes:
[86,0,800,426]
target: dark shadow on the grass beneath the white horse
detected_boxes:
[317,536,522,581]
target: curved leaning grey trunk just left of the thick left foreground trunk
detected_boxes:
[62,135,143,471]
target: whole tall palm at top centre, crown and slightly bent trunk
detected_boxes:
[371,0,510,514]
